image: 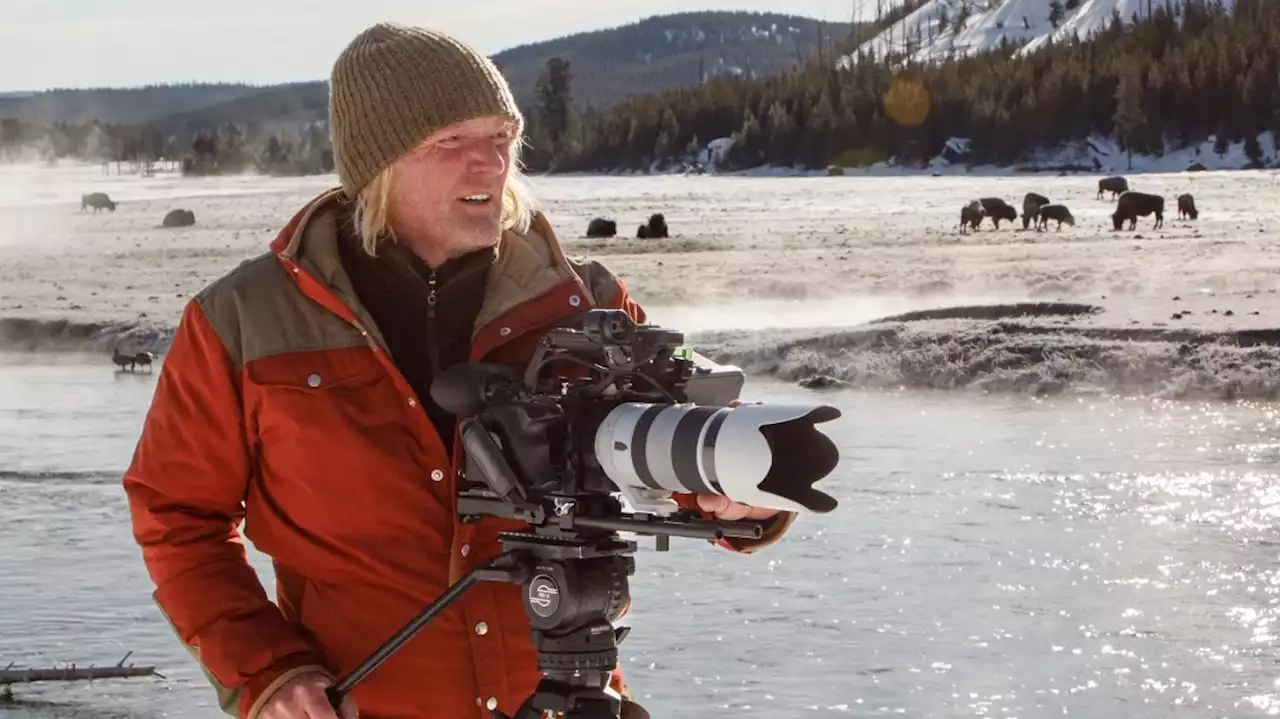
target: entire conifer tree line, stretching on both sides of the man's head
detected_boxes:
[0,0,1280,174]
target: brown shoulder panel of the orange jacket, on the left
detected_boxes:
[195,252,367,370]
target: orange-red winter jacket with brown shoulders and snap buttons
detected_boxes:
[123,191,794,719]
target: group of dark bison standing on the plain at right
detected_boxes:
[960,177,1199,234]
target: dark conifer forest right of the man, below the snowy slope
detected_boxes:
[526,0,1280,171]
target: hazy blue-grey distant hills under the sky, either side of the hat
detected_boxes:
[0,12,852,132]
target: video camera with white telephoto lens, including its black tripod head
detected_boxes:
[329,310,840,719]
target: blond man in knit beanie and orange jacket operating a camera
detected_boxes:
[124,24,794,719]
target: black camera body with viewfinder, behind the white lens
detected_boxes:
[431,310,745,519]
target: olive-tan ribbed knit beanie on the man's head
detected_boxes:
[329,23,524,197]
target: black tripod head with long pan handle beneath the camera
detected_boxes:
[325,532,635,719]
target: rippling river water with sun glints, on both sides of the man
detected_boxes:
[0,354,1280,719]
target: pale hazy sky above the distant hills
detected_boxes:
[0,0,874,92]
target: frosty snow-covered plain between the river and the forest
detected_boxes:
[0,159,1280,397]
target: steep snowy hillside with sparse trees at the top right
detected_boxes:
[840,0,1234,67]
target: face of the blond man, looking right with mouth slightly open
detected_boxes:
[387,116,516,265]
